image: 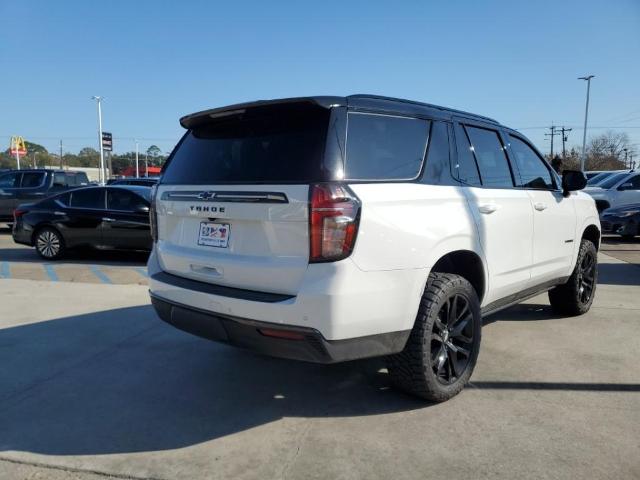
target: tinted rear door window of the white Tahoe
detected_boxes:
[465,127,513,188]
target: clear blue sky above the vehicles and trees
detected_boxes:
[0,0,640,158]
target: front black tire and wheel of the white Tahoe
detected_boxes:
[549,238,598,316]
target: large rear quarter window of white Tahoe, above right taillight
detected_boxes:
[344,113,429,180]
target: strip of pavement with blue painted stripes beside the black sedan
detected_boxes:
[0,228,148,285]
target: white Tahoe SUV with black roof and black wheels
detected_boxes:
[149,95,600,401]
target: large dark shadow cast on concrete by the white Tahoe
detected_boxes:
[0,306,429,455]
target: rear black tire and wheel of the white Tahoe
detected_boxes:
[387,272,482,402]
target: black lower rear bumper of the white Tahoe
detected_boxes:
[151,294,410,363]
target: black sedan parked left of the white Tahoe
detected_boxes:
[13,185,152,260]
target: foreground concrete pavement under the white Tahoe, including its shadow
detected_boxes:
[0,251,640,480]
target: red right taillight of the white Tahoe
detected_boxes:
[309,183,360,262]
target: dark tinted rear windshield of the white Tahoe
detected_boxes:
[162,106,329,184]
